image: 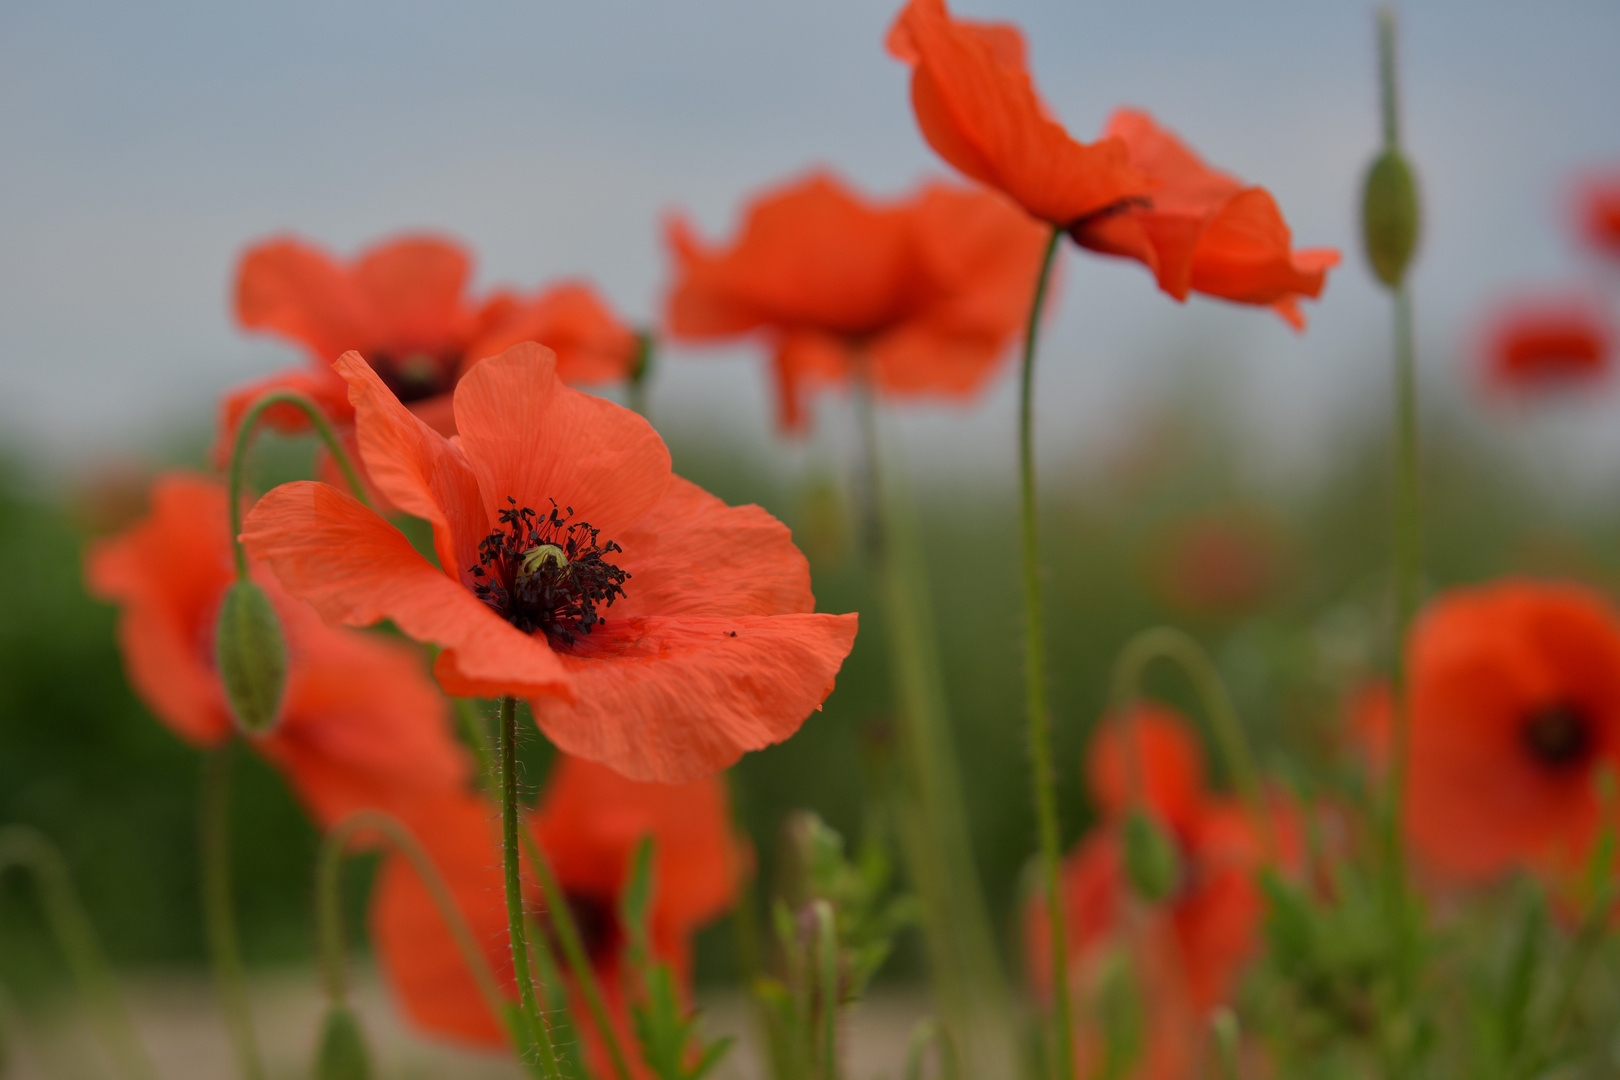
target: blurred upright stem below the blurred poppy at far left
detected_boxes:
[198,740,264,1080]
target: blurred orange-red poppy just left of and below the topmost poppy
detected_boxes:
[669,173,1043,429]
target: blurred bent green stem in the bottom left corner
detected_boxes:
[0,826,159,1080]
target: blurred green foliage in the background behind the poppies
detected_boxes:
[0,386,1620,991]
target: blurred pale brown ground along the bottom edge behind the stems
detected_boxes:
[0,968,927,1080]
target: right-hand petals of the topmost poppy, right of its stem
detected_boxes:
[1069,108,1338,330]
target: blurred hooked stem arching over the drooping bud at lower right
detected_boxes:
[1111,627,1277,858]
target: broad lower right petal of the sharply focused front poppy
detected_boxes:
[531,614,857,784]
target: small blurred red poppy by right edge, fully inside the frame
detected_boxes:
[1486,296,1614,393]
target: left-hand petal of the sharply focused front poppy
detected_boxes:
[241,481,573,698]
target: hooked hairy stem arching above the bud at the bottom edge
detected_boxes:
[314,810,505,1017]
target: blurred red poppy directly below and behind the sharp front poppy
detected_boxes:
[371,756,747,1075]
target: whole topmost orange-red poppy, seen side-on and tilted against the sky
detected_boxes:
[888,0,1338,329]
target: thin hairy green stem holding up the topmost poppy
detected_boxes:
[1017,227,1074,1080]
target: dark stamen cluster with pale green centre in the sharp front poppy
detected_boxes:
[470,495,630,644]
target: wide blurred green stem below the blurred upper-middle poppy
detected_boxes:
[855,367,1013,1072]
